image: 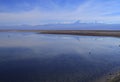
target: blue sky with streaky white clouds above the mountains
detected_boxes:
[0,0,120,25]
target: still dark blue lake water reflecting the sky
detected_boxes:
[0,32,120,82]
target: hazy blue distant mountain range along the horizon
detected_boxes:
[0,21,120,30]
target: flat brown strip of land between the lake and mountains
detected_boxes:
[0,30,120,37]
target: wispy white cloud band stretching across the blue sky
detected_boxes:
[0,0,120,24]
